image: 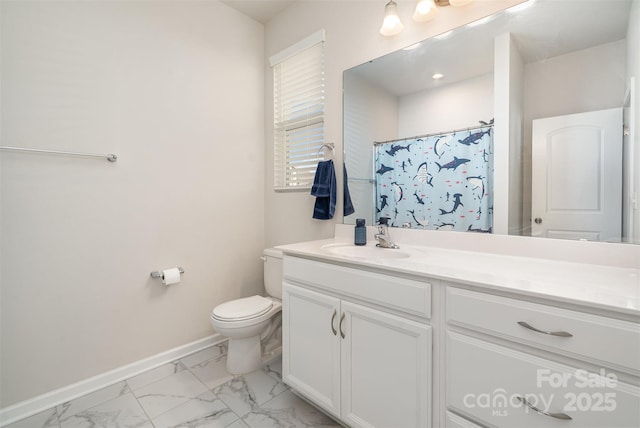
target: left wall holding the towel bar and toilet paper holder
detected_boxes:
[0,1,264,407]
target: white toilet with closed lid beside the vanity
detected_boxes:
[211,248,282,374]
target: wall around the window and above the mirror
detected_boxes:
[264,0,520,245]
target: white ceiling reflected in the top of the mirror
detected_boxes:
[351,0,632,96]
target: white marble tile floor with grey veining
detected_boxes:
[6,343,339,428]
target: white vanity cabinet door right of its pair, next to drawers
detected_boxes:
[340,301,431,428]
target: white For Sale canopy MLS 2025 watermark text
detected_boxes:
[462,369,618,419]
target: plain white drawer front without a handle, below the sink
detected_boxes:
[283,256,431,318]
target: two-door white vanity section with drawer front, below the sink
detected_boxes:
[283,256,431,428]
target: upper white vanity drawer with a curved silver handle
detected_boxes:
[446,287,640,371]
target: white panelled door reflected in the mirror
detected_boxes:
[531,108,622,241]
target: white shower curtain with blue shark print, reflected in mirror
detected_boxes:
[375,126,493,233]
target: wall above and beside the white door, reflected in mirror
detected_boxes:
[522,40,626,232]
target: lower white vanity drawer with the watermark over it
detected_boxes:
[446,332,640,428]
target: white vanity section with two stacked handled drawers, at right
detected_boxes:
[445,286,640,428]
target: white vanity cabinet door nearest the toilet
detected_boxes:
[282,282,340,417]
